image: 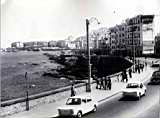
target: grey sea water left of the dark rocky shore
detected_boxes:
[1,51,70,101]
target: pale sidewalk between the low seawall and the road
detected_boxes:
[5,67,154,118]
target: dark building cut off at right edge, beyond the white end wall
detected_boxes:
[154,33,160,56]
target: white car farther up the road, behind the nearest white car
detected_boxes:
[123,82,146,99]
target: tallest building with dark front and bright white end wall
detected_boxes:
[127,15,154,55]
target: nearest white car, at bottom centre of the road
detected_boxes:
[58,96,98,118]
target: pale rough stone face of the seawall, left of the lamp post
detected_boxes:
[0,83,86,117]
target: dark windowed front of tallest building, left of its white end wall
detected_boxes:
[126,15,143,56]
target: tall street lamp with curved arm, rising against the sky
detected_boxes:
[86,17,100,92]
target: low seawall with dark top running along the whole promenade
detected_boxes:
[0,62,135,117]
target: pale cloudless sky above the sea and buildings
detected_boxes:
[1,0,160,48]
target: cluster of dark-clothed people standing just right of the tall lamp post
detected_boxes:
[95,76,112,90]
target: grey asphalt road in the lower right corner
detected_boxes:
[84,85,160,118]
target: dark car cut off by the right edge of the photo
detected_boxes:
[148,70,160,85]
